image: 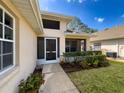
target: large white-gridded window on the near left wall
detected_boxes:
[0,7,15,72]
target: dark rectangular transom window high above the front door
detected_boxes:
[43,19,60,30]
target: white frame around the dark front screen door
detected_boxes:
[44,37,58,64]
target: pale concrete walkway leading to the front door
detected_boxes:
[39,64,79,93]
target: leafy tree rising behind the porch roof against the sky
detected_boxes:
[67,17,97,33]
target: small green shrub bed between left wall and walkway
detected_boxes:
[19,69,44,93]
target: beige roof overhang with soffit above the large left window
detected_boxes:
[11,0,43,34]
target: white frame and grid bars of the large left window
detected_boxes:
[0,5,16,75]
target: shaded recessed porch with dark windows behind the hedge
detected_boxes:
[65,33,89,52]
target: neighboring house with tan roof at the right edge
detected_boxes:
[90,25,124,57]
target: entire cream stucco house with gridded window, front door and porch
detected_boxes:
[0,0,89,93]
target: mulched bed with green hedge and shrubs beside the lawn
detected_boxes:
[60,51,109,72]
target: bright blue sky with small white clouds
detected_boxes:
[39,0,124,30]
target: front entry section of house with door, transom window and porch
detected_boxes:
[37,11,89,64]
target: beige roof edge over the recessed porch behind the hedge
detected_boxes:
[65,33,90,39]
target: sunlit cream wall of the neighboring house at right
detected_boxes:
[91,39,124,57]
